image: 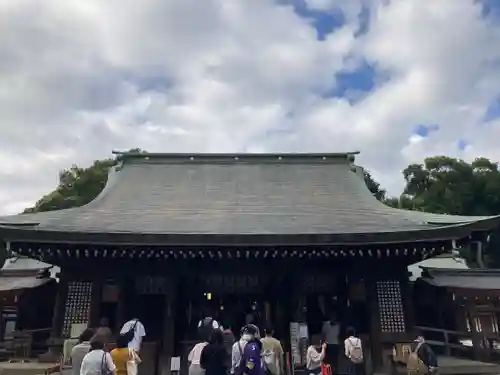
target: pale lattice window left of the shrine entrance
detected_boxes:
[63,281,92,337]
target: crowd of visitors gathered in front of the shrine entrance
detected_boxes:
[67,317,437,375]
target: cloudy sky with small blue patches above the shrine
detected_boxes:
[0,0,500,213]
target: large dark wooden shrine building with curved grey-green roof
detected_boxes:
[0,153,500,373]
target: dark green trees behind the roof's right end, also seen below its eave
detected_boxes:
[403,156,500,268]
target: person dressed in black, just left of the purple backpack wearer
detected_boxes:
[200,329,230,375]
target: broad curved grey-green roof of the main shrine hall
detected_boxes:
[0,154,498,245]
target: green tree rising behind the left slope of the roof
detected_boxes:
[24,149,143,213]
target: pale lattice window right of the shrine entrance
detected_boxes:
[377,281,406,332]
